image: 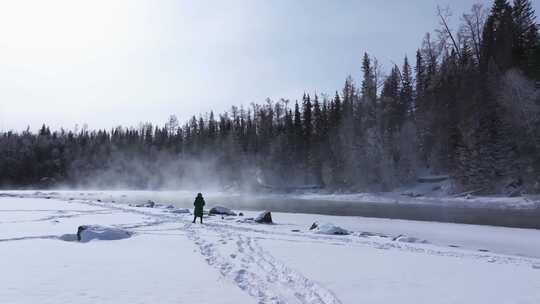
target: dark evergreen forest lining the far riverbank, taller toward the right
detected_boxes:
[0,0,540,193]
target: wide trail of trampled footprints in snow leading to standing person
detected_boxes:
[185,224,341,304]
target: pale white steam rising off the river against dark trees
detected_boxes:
[59,153,256,191]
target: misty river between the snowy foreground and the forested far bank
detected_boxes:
[0,190,540,229]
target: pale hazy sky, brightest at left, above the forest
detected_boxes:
[0,0,540,130]
